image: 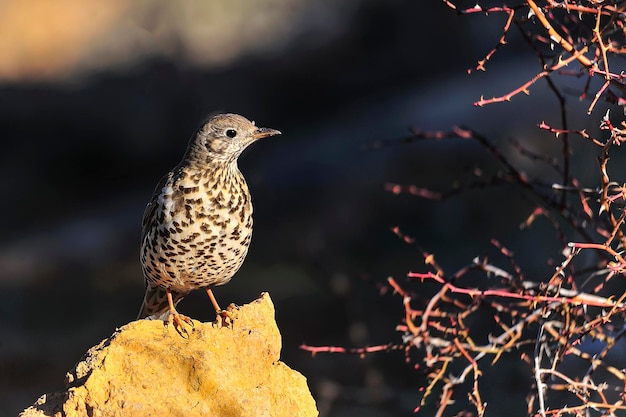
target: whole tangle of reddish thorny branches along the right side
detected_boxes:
[302,0,626,417]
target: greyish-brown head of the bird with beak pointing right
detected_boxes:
[186,113,280,163]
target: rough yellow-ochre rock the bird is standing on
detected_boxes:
[20,293,318,417]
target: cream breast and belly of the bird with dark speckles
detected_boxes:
[141,169,252,293]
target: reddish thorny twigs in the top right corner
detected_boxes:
[443,0,626,114]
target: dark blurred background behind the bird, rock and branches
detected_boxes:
[0,0,597,417]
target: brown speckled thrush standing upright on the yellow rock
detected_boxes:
[137,113,281,337]
